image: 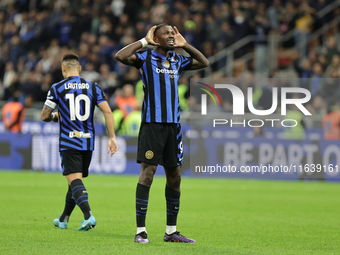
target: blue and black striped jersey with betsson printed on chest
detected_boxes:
[135,50,192,123]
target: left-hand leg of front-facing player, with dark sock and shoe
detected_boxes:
[135,163,157,243]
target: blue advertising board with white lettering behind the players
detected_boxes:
[0,122,340,180]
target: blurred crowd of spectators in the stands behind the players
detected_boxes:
[0,0,340,134]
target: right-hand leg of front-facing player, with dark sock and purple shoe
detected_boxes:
[164,166,195,243]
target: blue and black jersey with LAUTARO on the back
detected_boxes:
[45,76,106,151]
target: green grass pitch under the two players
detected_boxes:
[0,169,340,254]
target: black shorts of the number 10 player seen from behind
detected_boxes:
[60,150,92,177]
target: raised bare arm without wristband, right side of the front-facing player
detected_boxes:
[174,27,209,70]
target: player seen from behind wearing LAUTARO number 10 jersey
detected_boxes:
[41,54,118,230]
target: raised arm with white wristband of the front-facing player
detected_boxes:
[115,26,160,66]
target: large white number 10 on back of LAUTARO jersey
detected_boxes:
[65,94,91,121]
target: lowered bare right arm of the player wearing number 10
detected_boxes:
[98,101,118,157]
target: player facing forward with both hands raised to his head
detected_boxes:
[116,24,209,243]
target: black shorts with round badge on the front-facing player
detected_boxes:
[137,123,183,167]
